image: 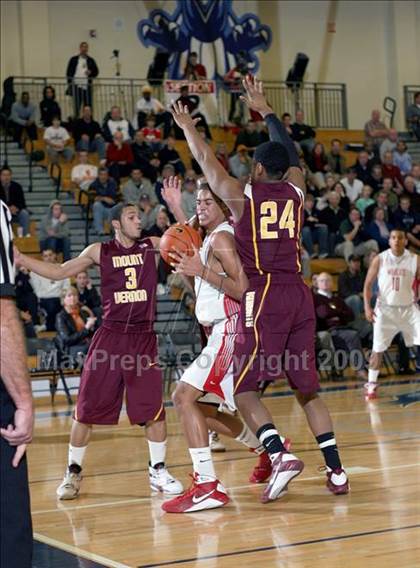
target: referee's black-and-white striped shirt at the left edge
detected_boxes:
[0,200,15,296]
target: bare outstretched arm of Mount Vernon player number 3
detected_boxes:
[14,243,101,280]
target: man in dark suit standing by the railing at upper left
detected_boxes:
[66,41,99,118]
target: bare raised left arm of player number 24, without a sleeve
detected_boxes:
[172,102,244,220]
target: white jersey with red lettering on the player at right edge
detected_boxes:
[378,249,417,306]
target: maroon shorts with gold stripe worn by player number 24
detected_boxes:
[233,274,319,394]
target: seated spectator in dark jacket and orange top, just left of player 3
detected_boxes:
[55,286,96,357]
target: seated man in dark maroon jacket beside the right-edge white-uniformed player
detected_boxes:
[313,272,367,379]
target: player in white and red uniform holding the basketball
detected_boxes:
[162,178,290,513]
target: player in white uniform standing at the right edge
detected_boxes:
[363,229,420,400]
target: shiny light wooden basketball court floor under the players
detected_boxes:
[29,375,420,568]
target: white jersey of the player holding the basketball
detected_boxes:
[194,221,240,326]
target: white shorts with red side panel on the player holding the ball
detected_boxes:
[181,313,239,410]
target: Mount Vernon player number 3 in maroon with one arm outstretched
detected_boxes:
[17,203,182,499]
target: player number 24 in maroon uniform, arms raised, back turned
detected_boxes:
[173,77,349,503]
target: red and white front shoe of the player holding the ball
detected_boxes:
[162,474,230,513]
